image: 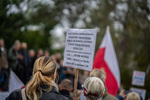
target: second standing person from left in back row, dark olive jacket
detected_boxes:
[8,40,23,75]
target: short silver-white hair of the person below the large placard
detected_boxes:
[83,77,105,100]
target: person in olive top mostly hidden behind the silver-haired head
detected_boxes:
[90,69,118,100]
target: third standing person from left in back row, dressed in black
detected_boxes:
[18,42,29,84]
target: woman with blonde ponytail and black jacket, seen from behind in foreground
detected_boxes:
[6,56,68,100]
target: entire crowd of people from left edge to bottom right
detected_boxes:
[0,38,145,100]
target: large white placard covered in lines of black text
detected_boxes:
[64,29,96,71]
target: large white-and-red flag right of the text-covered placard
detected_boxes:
[93,27,120,96]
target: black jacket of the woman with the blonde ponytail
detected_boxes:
[6,87,69,100]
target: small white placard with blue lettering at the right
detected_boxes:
[132,71,145,86]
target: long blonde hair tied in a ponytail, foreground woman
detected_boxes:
[26,56,57,100]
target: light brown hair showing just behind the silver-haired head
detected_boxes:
[90,69,106,82]
